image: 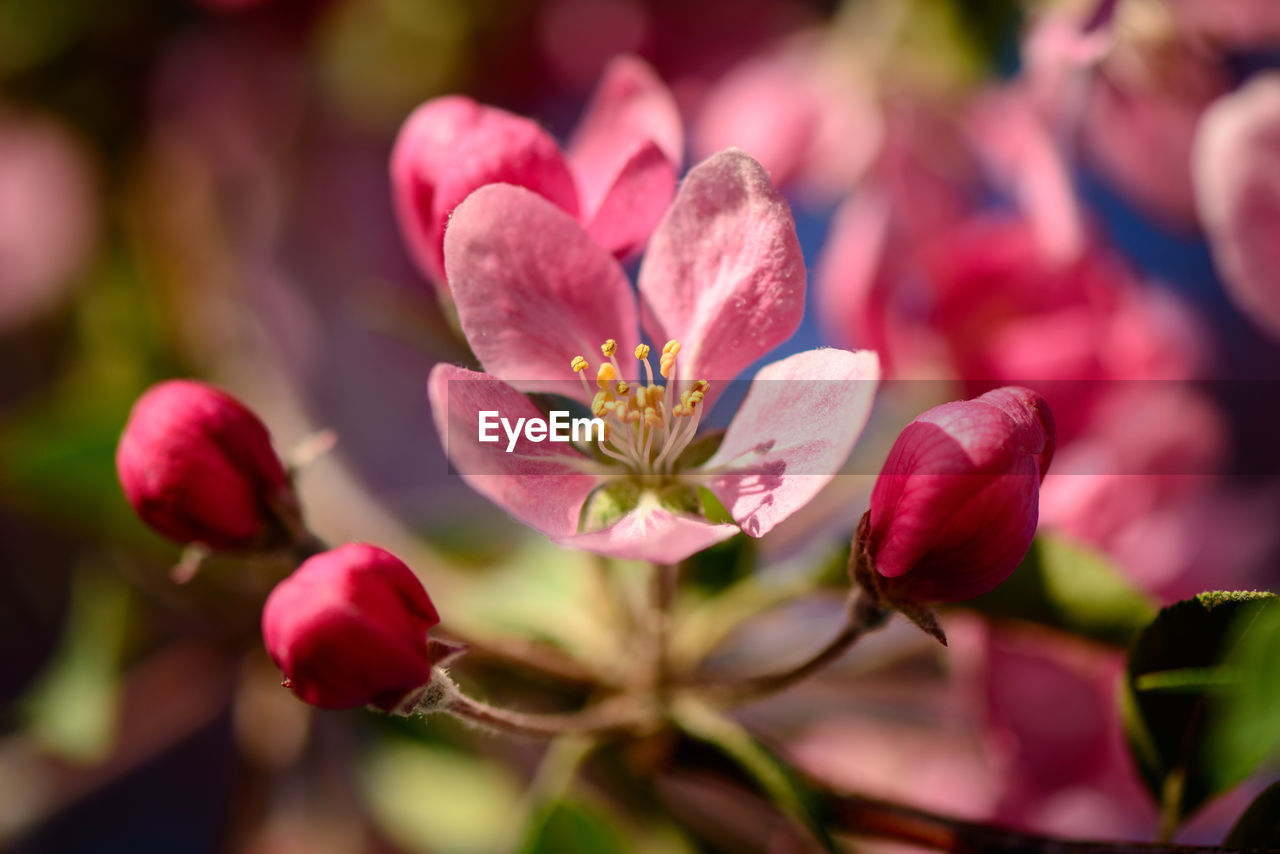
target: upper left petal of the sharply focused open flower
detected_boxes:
[444,184,637,397]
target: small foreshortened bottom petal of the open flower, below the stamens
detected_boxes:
[554,498,737,563]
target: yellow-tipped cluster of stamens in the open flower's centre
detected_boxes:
[570,338,710,475]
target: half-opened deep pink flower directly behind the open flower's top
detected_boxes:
[392,56,684,292]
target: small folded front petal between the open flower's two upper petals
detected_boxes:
[586,142,676,257]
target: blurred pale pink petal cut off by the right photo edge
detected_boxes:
[1193,73,1280,334]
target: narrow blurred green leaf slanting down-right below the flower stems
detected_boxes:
[673,698,840,851]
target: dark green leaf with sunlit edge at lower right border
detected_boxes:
[1121,592,1280,835]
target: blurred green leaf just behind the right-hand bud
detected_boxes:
[965,534,1156,647]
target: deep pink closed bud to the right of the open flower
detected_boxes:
[860,387,1055,602]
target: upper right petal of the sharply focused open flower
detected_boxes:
[640,149,805,396]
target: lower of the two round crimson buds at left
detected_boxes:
[262,543,440,712]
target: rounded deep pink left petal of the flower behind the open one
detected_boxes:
[392,95,579,288]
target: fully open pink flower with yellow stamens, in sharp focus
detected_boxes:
[429,150,879,562]
